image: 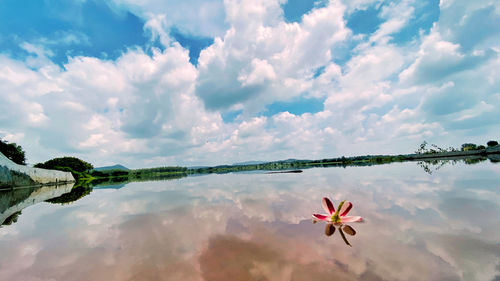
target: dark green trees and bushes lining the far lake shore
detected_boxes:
[3,140,500,188]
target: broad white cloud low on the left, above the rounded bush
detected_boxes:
[2,45,221,166]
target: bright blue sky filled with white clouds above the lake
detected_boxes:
[0,0,500,168]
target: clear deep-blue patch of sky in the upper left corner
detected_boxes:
[0,0,149,66]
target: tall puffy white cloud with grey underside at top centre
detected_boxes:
[196,0,349,116]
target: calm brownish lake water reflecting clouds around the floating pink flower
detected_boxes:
[0,162,500,281]
